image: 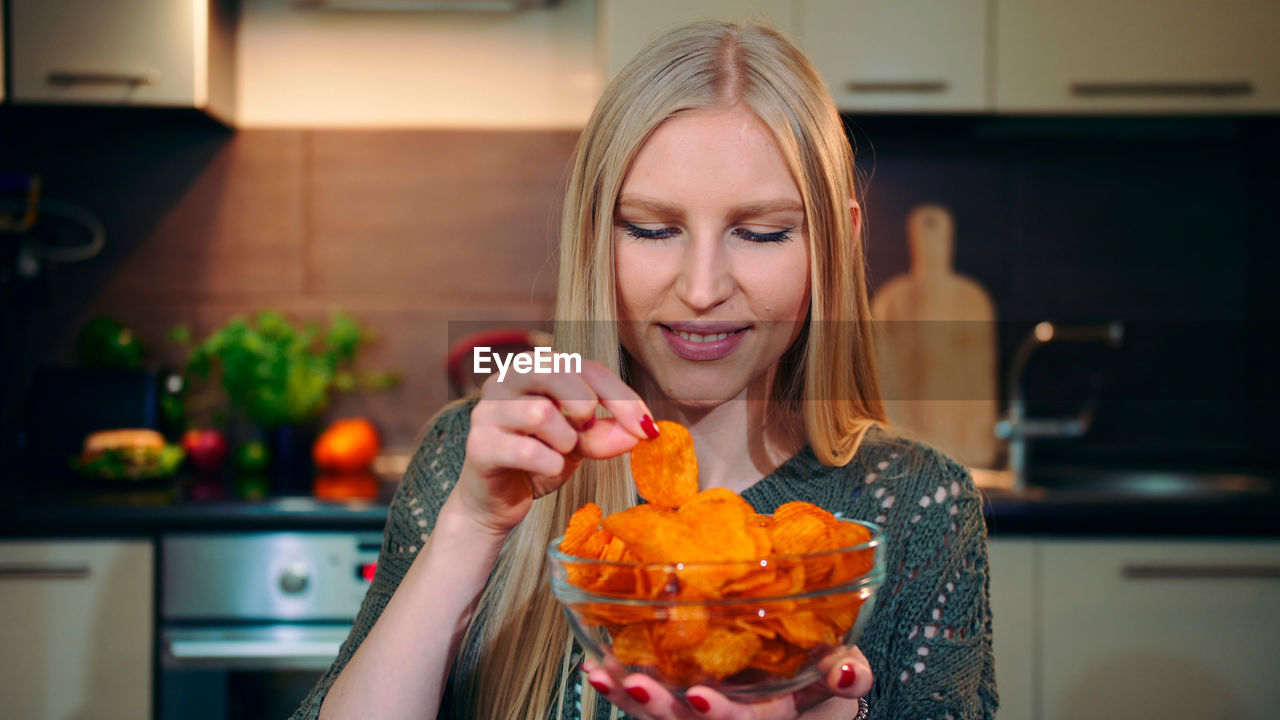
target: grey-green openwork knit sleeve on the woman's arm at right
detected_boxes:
[868,446,998,720]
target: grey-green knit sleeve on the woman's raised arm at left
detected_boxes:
[289,402,474,720]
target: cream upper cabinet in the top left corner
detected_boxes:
[9,0,236,123]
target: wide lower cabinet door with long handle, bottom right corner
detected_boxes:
[1039,541,1280,720]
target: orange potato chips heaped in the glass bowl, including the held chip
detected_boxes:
[559,420,874,685]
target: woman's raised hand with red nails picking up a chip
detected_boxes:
[454,360,658,536]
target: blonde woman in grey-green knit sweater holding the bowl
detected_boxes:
[294,23,997,719]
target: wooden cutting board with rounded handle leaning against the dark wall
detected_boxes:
[872,205,1002,468]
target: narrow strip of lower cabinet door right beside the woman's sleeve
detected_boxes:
[987,539,1037,720]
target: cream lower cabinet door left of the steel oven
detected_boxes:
[0,542,154,720]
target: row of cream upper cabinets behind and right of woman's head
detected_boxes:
[599,0,1280,114]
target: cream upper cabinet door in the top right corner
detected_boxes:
[993,0,1280,113]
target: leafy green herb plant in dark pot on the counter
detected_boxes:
[170,311,398,492]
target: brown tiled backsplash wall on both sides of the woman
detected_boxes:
[0,113,1280,471]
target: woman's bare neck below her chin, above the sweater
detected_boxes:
[636,373,805,492]
